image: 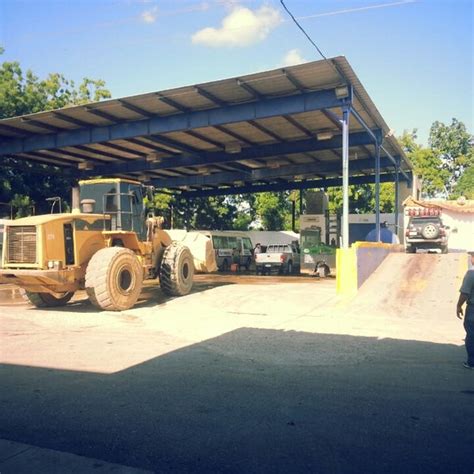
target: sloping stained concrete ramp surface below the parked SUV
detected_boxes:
[350,253,467,319]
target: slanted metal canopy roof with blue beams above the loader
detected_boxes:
[0,57,411,195]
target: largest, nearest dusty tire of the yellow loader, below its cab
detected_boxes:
[86,247,143,311]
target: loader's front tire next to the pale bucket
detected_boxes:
[160,242,194,296]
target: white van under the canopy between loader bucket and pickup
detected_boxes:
[199,230,253,272]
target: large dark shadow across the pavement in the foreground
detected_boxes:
[0,328,474,473]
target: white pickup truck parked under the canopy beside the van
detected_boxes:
[255,244,300,275]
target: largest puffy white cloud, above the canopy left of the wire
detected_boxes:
[192,5,282,47]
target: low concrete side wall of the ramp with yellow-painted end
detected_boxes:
[336,242,400,296]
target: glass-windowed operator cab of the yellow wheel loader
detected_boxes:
[79,178,146,240]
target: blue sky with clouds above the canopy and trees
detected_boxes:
[0,0,474,142]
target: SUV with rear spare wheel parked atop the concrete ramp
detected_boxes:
[405,216,449,253]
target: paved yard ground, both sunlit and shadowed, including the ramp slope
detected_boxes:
[0,255,474,474]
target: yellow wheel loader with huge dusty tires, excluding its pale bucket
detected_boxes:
[0,179,215,311]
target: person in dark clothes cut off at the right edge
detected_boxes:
[456,251,474,369]
